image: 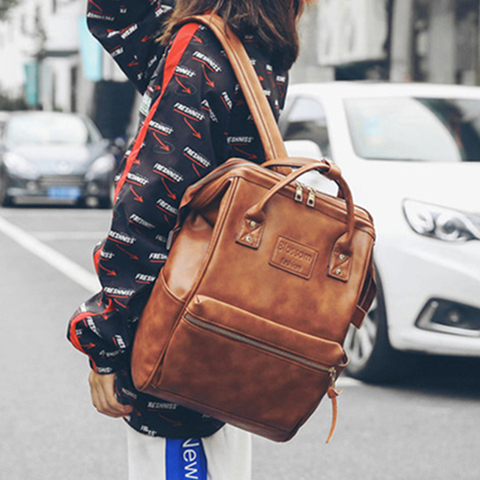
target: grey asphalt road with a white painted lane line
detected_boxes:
[0,208,480,480]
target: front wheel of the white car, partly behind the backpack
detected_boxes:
[345,275,413,383]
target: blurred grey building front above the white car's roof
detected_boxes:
[294,0,480,85]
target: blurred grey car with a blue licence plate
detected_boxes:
[0,111,116,207]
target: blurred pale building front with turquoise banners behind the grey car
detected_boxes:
[0,0,134,138]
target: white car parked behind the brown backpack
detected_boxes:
[280,82,480,381]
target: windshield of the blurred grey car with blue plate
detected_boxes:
[6,113,100,145]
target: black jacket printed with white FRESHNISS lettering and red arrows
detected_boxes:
[68,0,287,438]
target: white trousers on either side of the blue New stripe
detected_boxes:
[127,425,252,480]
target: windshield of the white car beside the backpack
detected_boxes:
[344,97,480,162]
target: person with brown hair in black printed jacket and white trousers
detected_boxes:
[68,0,303,480]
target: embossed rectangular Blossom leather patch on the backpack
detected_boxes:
[270,236,317,280]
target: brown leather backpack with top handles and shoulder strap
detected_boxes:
[132,16,375,441]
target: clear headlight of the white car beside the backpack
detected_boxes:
[403,200,480,242]
